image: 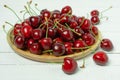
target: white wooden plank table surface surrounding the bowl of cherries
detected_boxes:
[0,0,120,80]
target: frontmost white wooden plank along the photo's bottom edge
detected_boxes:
[0,65,120,80]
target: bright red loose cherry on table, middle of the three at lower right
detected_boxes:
[93,51,108,65]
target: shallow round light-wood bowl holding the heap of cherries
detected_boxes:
[7,29,101,62]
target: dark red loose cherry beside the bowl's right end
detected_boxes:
[100,39,113,51]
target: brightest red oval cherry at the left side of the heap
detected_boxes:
[21,25,32,38]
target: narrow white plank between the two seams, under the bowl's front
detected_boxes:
[0,53,120,67]
